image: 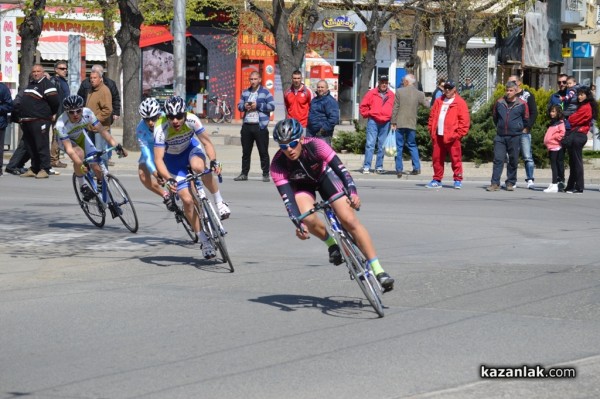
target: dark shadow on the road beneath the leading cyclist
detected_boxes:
[249,295,378,318]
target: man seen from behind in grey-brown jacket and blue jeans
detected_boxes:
[392,74,429,178]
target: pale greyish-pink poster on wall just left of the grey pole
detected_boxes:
[142,47,175,95]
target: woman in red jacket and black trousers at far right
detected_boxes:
[565,86,598,194]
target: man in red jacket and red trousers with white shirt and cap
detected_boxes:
[426,79,471,190]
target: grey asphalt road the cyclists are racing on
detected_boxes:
[0,176,600,399]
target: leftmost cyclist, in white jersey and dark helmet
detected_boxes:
[54,95,127,201]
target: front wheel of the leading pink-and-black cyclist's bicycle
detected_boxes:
[339,236,384,317]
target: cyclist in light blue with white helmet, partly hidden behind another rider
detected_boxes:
[135,98,176,211]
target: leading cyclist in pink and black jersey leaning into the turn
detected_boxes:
[270,119,394,291]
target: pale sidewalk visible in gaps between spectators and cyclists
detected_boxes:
[4,122,600,188]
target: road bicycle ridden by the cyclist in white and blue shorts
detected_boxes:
[179,169,235,273]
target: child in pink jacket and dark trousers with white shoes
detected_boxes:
[544,105,566,193]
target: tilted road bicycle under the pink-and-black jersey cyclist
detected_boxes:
[292,191,384,317]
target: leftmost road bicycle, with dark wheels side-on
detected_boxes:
[73,147,139,233]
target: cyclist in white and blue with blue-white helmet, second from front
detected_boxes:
[154,96,231,259]
